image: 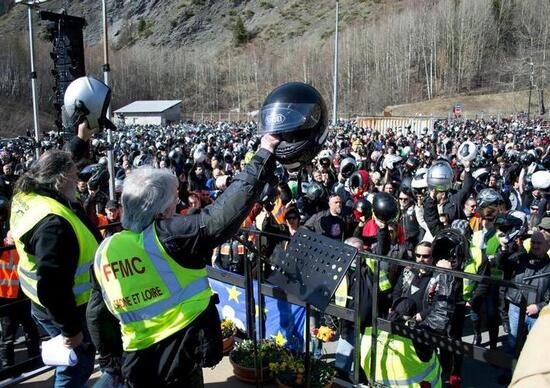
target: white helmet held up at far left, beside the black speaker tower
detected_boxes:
[61,77,116,130]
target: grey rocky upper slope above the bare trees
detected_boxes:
[0,0,390,55]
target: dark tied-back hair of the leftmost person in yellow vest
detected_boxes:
[15,150,75,193]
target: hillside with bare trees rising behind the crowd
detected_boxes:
[0,0,550,134]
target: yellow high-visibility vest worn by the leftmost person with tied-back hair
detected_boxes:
[10,193,98,306]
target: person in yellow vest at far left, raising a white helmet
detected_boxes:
[10,77,111,387]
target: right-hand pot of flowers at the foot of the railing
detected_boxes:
[269,351,336,388]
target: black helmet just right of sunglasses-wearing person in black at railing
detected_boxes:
[432,229,470,270]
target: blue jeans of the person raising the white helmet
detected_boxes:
[31,304,95,388]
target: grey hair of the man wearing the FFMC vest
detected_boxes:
[121,167,178,233]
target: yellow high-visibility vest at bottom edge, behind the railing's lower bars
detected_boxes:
[361,327,442,387]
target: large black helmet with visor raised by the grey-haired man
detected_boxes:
[258,82,328,171]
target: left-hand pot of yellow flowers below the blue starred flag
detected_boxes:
[229,339,284,383]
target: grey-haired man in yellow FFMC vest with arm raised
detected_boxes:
[88,134,279,387]
